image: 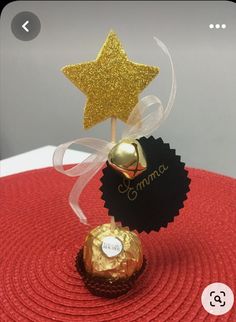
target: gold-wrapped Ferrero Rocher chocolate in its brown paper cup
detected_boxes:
[75,223,146,298]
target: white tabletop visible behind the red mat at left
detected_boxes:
[0,145,89,177]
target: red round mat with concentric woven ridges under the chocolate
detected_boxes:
[0,168,236,322]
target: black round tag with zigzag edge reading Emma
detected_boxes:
[100,136,190,233]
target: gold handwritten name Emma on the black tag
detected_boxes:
[118,164,168,201]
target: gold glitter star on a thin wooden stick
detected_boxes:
[62,31,159,128]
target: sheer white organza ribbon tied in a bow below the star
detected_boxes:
[53,37,176,224]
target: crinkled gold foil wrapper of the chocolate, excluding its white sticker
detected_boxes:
[83,224,143,279]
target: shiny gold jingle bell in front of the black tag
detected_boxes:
[108,139,147,179]
